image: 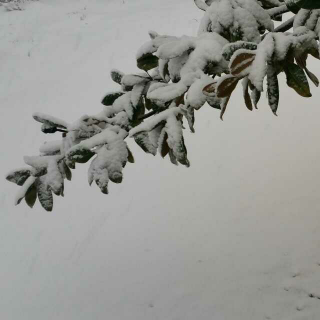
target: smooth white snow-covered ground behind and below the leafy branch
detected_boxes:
[0,0,320,320]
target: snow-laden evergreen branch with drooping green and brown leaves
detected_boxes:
[5,0,320,211]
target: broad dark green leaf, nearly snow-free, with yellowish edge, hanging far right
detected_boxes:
[284,63,312,98]
